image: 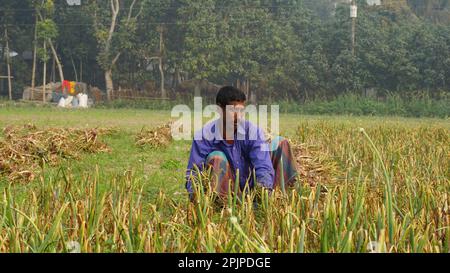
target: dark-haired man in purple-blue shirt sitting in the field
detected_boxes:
[186,86,297,199]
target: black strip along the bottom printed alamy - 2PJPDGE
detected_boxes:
[0,253,450,273]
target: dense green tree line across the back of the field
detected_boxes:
[0,0,450,101]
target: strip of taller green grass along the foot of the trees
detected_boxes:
[0,91,450,118]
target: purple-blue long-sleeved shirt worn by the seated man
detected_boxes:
[186,119,275,193]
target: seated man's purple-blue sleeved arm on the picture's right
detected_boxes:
[249,128,275,189]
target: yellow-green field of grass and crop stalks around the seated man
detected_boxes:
[0,107,450,253]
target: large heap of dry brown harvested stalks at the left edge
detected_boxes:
[0,124,112,181]
